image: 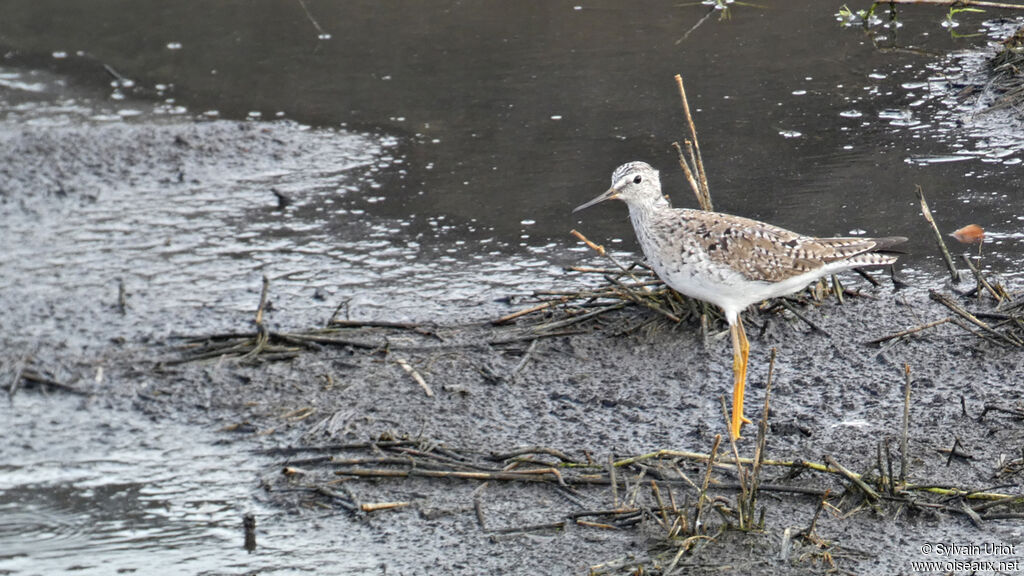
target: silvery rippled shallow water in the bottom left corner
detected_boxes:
[0,392,391,575]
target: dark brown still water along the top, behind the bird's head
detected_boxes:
[3,1,1020,253]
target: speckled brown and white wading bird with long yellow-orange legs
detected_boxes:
[572,162,906,438]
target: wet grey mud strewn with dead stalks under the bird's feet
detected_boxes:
[36,266,1024,574]
